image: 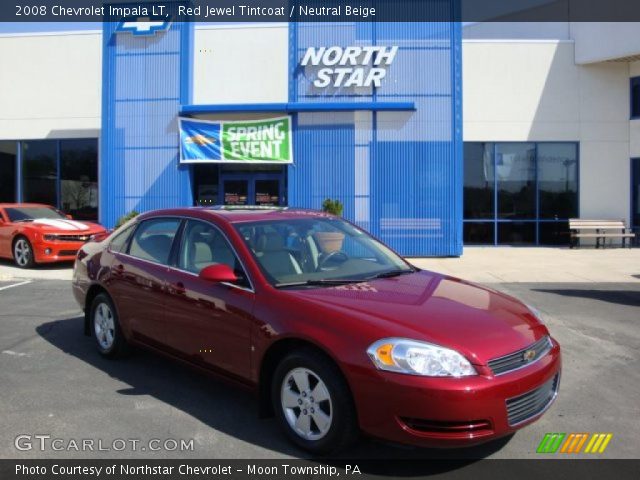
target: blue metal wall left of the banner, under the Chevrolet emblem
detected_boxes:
[100,11,193,227]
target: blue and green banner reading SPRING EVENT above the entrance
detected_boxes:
[178,115,293,164]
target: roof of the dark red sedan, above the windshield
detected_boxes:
[138,205,332,223]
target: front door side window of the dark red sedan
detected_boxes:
[178,220,250,287]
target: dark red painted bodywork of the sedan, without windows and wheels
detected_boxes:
[73,208,561,447]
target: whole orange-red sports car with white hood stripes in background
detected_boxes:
[0,203,106,268]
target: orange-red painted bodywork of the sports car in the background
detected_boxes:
[0,203,105,263]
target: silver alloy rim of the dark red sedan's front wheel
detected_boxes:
[280,368,333,440]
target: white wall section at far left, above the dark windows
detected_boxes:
[0,32,102,139]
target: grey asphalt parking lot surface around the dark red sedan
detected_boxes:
[0,279,640,459]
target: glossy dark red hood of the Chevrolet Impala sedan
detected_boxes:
[288,271,548,364]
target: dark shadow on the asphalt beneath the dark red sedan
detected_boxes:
[36,317,511,470]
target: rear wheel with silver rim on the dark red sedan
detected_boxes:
[89,293,129,358]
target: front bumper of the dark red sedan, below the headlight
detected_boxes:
[351,340,561,447]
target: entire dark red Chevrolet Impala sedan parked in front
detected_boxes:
[73,207,560,453]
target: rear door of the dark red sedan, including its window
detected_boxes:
[109,217,181,348]
